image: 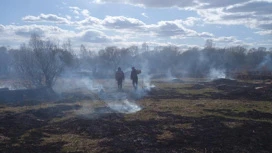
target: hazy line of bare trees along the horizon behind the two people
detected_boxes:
[0,34,272,88]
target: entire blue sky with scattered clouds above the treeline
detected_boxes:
[0,0,272,50]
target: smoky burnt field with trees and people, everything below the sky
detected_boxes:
[0,34,272,153]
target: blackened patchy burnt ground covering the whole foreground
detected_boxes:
[0,80,272,153]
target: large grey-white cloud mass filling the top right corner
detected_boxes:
[93,0,272,34]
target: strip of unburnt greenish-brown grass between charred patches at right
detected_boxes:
[137,99,272,122]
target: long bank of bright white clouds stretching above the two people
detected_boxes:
[76,16,213,41]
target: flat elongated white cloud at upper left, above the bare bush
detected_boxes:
[22,14,70,24]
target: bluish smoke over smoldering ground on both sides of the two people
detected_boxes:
[51,69,154,118]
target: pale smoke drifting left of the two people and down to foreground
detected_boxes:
[54,70,145,118]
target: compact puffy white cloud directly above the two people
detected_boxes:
[103,16,145,30]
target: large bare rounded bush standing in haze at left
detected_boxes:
[14,34,73,88]
